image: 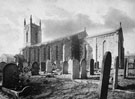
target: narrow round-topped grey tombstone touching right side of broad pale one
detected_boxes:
[81,59,87,79]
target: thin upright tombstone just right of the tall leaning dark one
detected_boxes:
[113,56,119,90]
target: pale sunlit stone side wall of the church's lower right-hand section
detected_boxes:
[85,33,118,67]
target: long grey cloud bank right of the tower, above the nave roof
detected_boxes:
[42,14,97,39]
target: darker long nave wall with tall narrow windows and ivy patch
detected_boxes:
[23,31,87,70]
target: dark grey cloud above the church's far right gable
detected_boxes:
[104,9,135,32]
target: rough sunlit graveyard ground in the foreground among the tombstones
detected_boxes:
[0,70,135,99]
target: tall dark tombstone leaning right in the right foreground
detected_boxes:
[99,52,112,99]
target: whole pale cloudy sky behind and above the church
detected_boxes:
[0,0,135,55]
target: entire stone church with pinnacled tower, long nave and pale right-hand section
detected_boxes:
[22,16,124,71]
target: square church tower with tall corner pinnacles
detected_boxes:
[24,15,41,46]
